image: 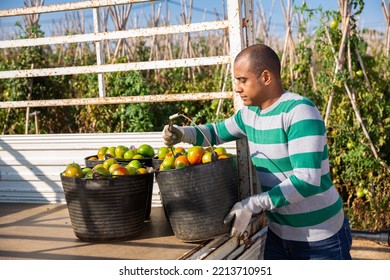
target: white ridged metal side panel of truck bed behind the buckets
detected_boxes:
[0,132,236,202]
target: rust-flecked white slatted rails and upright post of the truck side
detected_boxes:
[0,0,256,201]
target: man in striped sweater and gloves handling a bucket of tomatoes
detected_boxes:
[163,44,352,259]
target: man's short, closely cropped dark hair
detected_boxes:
[235,44,281,78]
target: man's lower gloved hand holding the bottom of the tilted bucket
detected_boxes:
[223,202,252,237]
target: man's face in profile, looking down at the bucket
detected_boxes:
[234,57,265,106]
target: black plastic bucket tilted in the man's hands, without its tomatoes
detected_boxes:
[155,156,239,242]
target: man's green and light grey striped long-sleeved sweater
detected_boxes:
[184,92,344,241]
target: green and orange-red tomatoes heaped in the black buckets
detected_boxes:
[62,144,233,179]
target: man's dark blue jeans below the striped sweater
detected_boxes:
[264,218,352,260]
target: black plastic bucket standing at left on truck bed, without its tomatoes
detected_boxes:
[61,173,153,242]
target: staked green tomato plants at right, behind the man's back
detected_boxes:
[283,1,390,230]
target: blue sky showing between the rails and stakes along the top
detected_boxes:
[0,0,389,39]
